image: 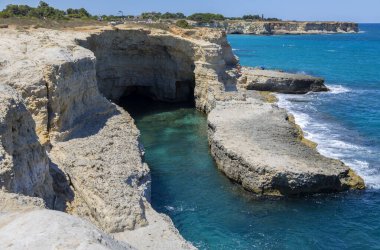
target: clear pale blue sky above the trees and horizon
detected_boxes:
[0,0,380,23]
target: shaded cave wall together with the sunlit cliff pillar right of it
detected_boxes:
[80,29,237,112]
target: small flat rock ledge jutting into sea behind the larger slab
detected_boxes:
[238,67,328,94]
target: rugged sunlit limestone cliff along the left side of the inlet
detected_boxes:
[0,26,196,249]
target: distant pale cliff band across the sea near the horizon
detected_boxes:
[197,20,359,35]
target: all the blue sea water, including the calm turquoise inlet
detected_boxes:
[126,24,380,249]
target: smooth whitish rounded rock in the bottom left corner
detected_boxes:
[0,209,134,250]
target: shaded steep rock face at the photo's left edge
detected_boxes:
[0,84,54,208]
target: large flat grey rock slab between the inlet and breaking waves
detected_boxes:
[208,92,364,196]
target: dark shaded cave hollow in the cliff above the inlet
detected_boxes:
[82,30,199,106]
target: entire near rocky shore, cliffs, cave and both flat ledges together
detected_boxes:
[0,26,364,249]
